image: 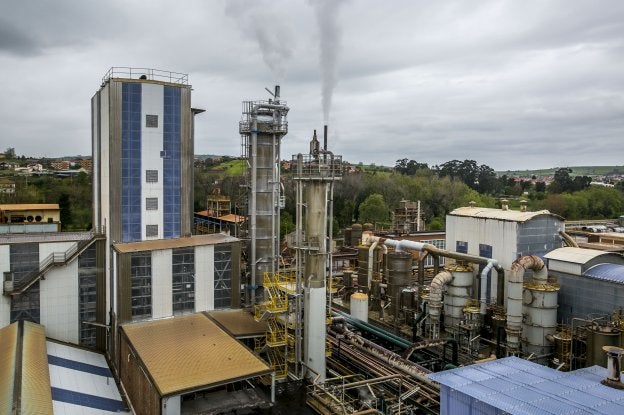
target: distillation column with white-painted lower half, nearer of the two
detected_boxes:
[292,127,342,381]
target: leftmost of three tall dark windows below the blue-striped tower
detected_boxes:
[130,252,152,321]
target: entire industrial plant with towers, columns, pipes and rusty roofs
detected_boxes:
[0,67,624,415]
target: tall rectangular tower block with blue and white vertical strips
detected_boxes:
[91,68,193,243]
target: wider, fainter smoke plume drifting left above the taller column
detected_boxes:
[225,0,295,82]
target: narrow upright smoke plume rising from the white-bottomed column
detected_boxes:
[310,0,345,124]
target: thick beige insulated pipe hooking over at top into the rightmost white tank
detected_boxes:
[506,255,548,355]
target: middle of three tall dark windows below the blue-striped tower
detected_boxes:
[171,248,195,315]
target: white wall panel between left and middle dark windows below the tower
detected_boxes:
[152,249,173,318]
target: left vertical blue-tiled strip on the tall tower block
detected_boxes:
[121,82,141,242]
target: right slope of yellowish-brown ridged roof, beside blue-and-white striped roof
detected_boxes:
[21,321,53,414]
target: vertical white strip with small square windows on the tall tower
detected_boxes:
[141,83,164,239]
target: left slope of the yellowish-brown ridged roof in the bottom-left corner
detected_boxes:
[0,323,17,414]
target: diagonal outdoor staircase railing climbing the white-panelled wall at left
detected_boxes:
[4,229,106,295]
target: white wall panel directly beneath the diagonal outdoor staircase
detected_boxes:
[39,262,80,343]
